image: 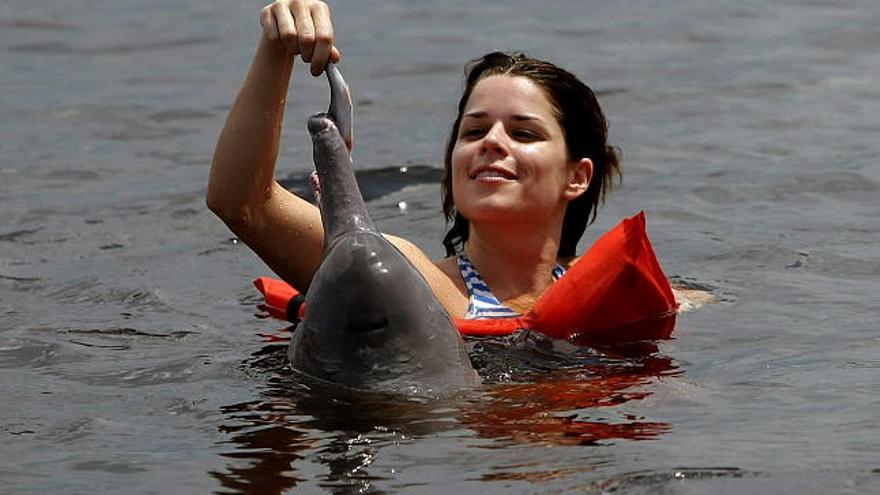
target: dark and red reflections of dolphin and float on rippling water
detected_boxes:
[210,332,679,494]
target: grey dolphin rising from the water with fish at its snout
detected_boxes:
[288,65,479,396]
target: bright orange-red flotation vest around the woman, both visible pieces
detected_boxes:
[254,212,678,343]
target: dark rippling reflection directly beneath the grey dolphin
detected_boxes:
[210,345,457,494]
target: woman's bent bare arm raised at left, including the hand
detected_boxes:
[206,0,340,290]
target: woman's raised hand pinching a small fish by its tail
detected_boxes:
[260,0,341,76]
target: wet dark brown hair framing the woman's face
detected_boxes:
[443,52,621,257]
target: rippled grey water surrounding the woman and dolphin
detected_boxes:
[0,0,880,494]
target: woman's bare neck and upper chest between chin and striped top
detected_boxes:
[465,219,562,306]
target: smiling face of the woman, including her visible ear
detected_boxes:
[452,75,592,229]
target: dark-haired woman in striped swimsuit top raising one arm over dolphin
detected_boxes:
[207,0,620,324]
